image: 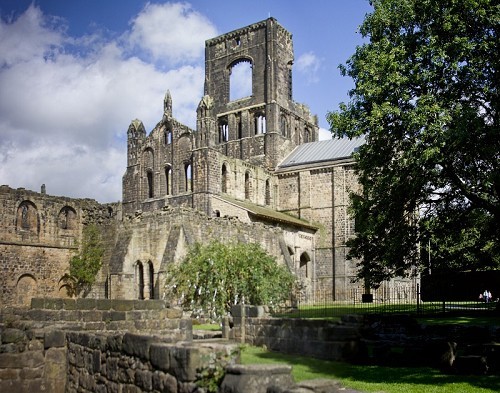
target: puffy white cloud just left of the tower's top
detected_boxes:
[130,3,217,65]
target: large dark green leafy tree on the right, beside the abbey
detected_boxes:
[328,0,500,286]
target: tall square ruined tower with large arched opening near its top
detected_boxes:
[197,18,318,167]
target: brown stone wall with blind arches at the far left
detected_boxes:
[0,186,114,305]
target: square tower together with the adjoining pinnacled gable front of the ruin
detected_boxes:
[123,18,318,215]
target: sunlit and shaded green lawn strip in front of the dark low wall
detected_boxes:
[241,346,500,393]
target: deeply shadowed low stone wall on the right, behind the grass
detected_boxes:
[229,305,500,374]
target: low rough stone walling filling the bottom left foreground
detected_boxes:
[0,299,239,393]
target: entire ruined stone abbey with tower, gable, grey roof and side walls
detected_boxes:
[0,18,411,306]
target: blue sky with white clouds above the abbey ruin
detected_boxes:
[0,0,371,202]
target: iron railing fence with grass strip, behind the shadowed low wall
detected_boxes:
[275,284,498,319]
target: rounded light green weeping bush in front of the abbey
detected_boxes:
[165,241,295,319]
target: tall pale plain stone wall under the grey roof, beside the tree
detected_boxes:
[278,160,359,300]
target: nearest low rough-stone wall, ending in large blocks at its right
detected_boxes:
[66,332,239,393]
